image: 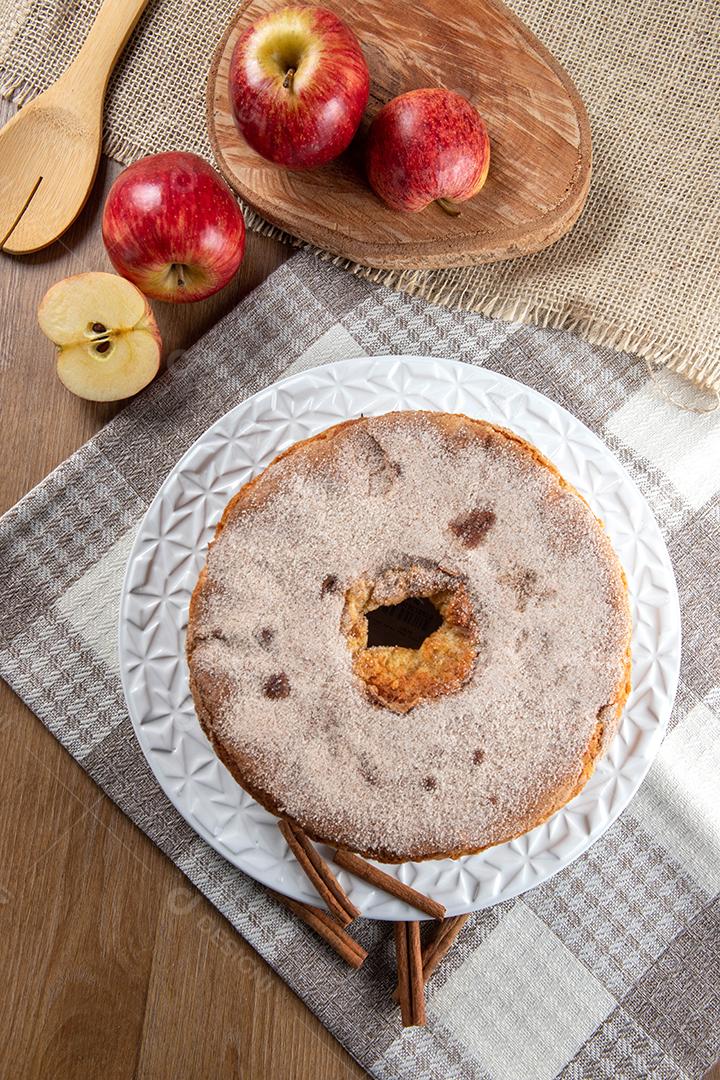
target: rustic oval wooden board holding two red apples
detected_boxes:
[207,0,590,269]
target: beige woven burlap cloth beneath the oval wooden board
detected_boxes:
[0,0,720,389]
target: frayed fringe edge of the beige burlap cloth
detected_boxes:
[0,70,720,411]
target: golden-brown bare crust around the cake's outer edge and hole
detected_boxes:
[187,413,631,862]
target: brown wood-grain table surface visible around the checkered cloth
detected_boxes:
[0,95,365,1080]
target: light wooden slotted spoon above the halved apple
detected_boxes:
[0,0,148,254]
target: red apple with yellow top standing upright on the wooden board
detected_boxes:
[230,5,370,168]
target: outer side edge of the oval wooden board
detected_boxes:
[206,0,592,270]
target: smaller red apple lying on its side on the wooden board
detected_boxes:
[366,90,490,213]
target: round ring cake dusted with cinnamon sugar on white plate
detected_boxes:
[187,411,630,862]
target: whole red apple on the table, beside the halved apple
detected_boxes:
[103,153,245,302]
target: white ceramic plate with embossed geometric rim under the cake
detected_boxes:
[120,356,680,919]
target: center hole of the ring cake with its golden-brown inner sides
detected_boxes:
[341,561,479,713]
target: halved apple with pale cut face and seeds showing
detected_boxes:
[38,271,162,402]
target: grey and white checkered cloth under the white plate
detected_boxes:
[0,255,720,1080]
